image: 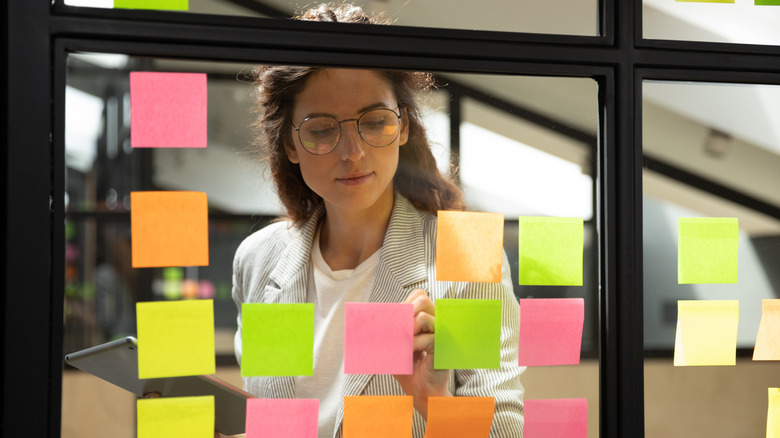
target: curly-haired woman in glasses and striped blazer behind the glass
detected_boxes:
[233,5,523,437]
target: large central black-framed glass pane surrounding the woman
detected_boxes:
[62,53,600,437]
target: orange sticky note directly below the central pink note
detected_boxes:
[343,395,414,438]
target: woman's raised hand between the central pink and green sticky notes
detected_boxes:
[393,289,452,419]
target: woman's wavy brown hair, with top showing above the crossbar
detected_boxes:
[253,4,463,223]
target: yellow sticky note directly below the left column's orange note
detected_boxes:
[136,300,216,379]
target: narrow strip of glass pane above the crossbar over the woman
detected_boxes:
[64,0,599,36]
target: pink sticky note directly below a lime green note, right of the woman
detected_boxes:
[518,298,585,366]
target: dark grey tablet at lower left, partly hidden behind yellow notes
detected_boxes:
[65,336,254,435]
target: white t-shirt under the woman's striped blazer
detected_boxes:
[295,232,381,438]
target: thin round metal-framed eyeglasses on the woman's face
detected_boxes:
[293,107,401,155]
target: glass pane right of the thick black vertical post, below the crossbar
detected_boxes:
[643,82,780,437]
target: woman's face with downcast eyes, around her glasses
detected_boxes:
[286,69,408,217]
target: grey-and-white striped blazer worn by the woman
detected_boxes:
[233,194,524,438]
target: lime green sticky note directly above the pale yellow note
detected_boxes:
[677,218,739,284]
